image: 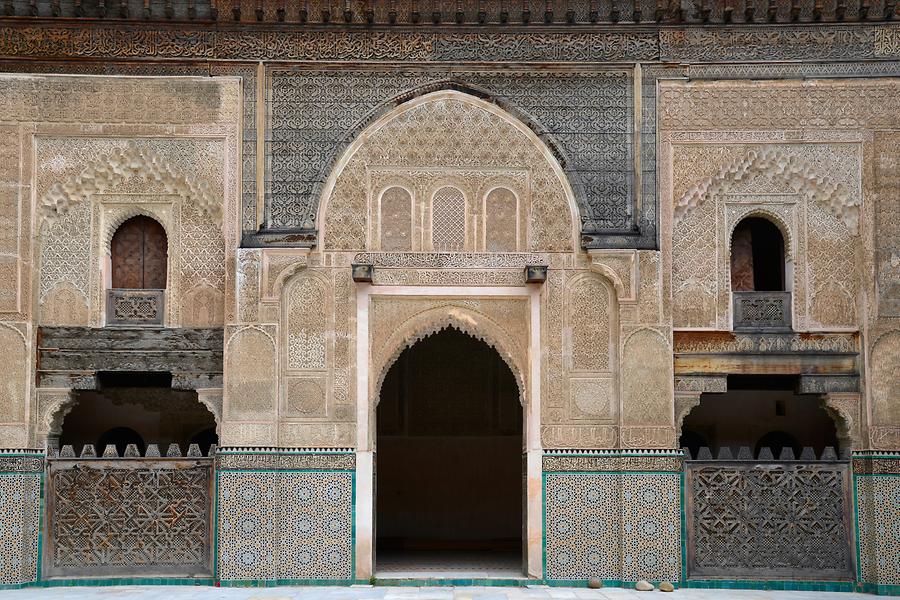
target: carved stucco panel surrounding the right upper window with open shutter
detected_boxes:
[672,145,862,330]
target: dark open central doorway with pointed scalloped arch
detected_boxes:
[375,327,525,578]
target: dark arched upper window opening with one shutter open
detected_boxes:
[731,217,785,292]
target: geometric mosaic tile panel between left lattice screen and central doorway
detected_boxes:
[218,471,354,581]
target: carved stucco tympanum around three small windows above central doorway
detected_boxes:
[318,91,580,252]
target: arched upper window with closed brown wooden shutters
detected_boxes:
[110,216,169,290]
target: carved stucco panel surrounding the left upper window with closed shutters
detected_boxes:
[35,135,234,326]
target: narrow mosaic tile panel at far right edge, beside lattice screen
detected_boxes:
[854,474,900,586]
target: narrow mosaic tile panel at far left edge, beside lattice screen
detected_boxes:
[0,473,42,585]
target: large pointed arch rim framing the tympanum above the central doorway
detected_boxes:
[311,78,594,236]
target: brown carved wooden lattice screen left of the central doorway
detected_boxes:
[44,458,212,577]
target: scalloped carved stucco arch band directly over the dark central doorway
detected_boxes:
[369,305,528,412]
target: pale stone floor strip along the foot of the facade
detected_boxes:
[0,586,875,600]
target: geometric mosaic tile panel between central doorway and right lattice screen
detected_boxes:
[544,473,681,582]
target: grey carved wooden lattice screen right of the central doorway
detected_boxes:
[685,460,853,581]
